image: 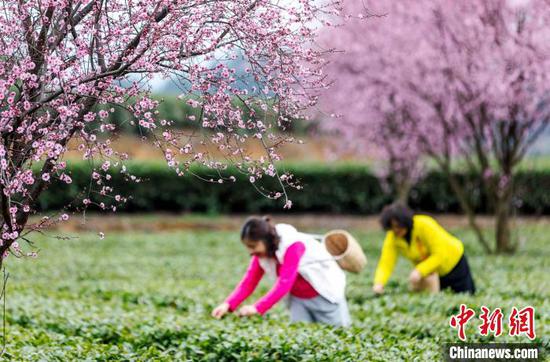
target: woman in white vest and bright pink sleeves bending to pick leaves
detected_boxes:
[212,217,350,326]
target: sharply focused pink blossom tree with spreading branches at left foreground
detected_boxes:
[0,0,339,266]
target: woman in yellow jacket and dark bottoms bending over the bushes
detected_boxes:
[373,203,475,294]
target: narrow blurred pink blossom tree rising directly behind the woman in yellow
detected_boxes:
[320,1,424,203]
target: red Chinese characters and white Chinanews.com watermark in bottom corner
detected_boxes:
[443,304,544,361]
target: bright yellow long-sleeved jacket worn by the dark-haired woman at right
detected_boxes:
[374,215,464,285]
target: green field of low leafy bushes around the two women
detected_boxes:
[4,216,550,361]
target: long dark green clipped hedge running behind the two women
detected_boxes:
[39,162,550,214]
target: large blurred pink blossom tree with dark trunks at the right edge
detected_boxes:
[325,0,550,252]
